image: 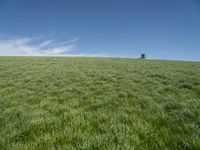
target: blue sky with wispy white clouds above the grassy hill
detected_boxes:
[0,0,200,61]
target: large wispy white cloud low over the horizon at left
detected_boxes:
[0,36,79,56]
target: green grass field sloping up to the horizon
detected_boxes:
[0,57,200,150]
